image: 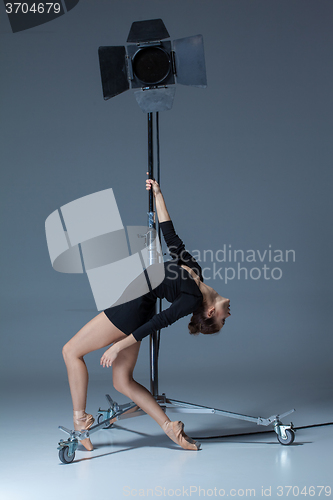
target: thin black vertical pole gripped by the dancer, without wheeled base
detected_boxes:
[147,113,158,396]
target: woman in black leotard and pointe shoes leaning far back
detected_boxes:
[63,179,230,450]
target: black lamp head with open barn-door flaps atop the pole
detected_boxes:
[98,19,207,113]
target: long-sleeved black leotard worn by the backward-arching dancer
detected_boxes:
[104,221,203,341]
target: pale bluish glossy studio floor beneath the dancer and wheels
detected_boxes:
[0,382,333,500]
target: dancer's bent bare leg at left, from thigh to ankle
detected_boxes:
[62,313,126,410]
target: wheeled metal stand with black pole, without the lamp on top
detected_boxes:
[58,112,295,463]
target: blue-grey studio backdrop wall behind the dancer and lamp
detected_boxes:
[0,0,333,428]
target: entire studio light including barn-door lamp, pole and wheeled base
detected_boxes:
[58,19,295,463]
